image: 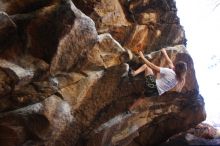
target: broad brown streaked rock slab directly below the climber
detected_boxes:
[89,90,205,145]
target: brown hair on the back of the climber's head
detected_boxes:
[174,61,187,81]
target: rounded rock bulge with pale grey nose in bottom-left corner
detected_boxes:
[0,96,74,146]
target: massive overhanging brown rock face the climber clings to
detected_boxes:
[0,0,206,146]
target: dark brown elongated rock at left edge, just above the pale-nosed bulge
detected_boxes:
[0,81,57,112]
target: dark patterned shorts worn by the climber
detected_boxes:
[144,75,159,97]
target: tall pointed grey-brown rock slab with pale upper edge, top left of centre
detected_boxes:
[50,1,98,73]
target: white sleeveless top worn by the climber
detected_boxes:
[156,67,178,95]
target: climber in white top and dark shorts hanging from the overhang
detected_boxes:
[129,48,187,111]
